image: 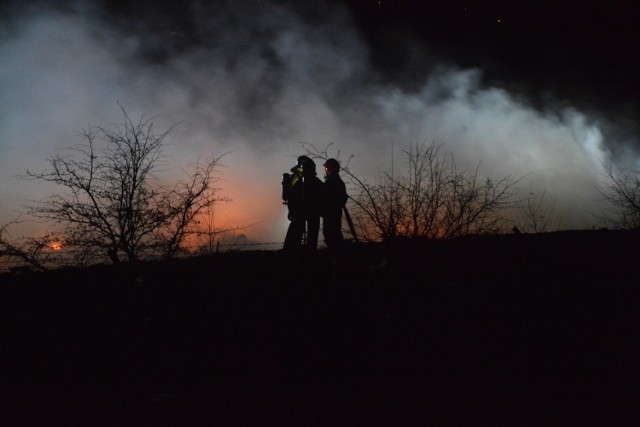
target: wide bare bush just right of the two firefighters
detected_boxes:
[303,143,519,240]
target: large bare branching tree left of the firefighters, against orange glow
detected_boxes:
[25,107,228,263]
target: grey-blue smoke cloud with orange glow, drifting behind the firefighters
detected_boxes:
[0,1,635,241]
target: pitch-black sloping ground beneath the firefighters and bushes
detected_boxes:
[0,231,640,426]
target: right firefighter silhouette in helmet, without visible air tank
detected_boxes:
[322,159,349,250]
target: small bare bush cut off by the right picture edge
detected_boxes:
[599,161,640,229]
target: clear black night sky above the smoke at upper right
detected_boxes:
[346,0,640,108]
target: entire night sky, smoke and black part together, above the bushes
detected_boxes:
[0,0,640,246]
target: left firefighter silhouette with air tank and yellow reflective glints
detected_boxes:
[282,156,324,251]
